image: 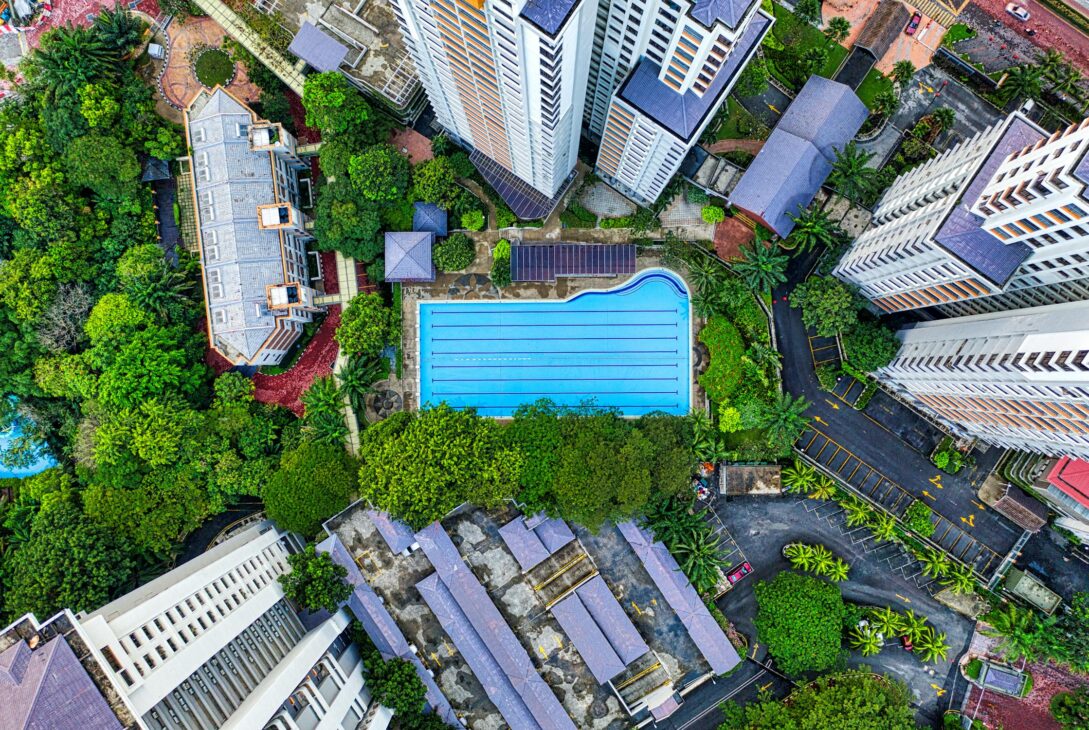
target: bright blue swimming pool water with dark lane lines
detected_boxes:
[419,269,692,416]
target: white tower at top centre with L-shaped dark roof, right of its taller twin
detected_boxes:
[587,0,773,205]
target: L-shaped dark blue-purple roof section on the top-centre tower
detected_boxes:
[617,11,771,142]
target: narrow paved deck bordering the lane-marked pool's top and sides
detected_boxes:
[400,243,707,411]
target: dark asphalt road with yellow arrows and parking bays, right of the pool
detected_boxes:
[773,254,1021,575]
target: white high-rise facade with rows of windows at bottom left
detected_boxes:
[70,522,391,730]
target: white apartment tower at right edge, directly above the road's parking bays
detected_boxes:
[878,302,1089,459]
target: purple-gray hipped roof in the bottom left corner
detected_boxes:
[0,636,121,730]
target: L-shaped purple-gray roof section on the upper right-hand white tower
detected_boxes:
[934,115,1048,287]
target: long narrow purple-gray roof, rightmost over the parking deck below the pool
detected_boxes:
[616,522,742,674]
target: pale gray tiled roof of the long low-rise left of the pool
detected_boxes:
[186,89,300,360]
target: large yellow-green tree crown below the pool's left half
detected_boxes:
[359,404,524,528]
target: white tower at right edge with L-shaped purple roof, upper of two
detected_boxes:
[835,114,1089,315]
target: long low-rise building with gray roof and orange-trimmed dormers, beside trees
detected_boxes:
[185,87,317,365]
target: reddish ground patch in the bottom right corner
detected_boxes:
[966,664,1089,730]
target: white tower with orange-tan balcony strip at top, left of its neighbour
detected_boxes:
[393,0,597,218]
